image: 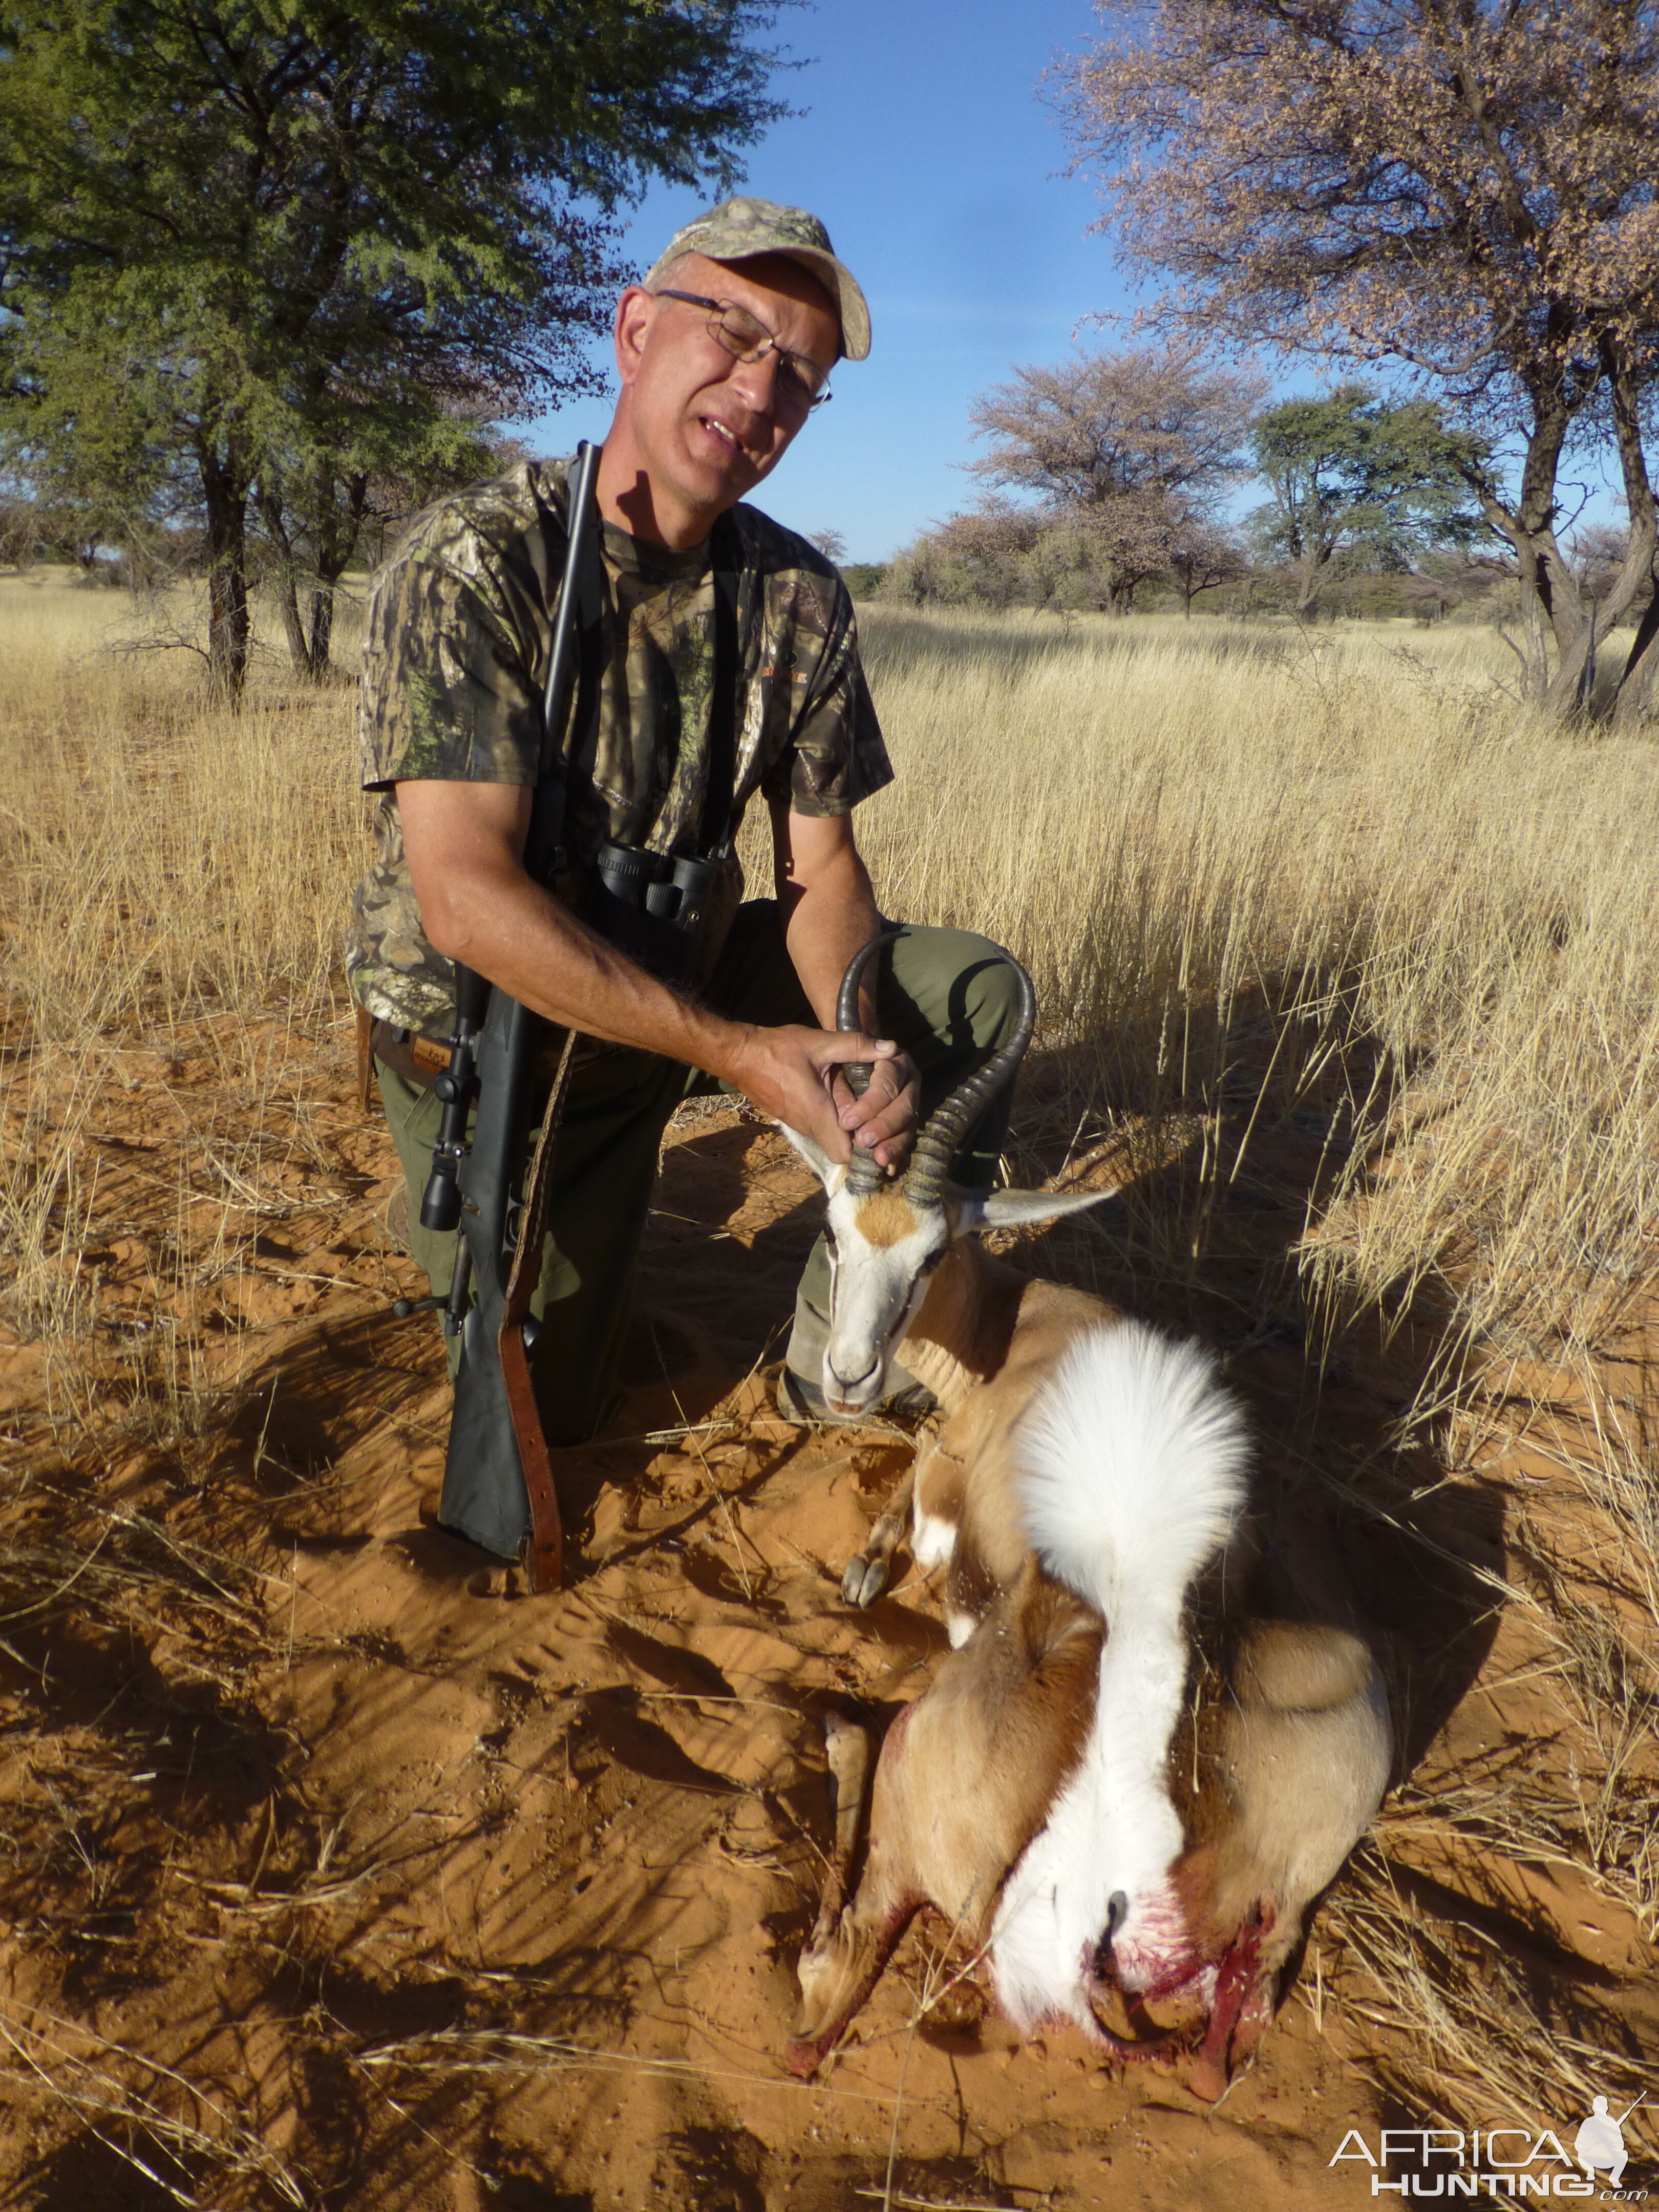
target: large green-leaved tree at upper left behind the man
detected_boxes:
[0,0,779,692]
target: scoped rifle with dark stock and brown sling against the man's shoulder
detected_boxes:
[394,440,600,1590]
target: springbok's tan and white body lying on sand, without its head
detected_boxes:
[790,1285,1391,2099]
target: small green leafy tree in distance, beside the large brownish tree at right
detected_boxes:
[1250,385,1484,615]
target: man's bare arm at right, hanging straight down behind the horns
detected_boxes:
[772,799,920,1168]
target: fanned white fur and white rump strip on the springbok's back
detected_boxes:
[991,1321,1250,2033]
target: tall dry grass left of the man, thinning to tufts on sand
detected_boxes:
[0,578,360,1427]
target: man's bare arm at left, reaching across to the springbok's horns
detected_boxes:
[398,781,903,1159]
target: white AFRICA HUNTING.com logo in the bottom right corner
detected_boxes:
[1329,2090,1648,2203]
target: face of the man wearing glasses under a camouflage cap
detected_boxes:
[606,254,841,544]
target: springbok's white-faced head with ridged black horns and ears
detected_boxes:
[783,931,1113,1413]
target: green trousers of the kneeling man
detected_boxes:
[376,900,1017,1444]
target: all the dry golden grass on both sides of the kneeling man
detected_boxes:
[0,578,1659,2203]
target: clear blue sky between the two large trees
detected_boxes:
[524,0,1126,560]
